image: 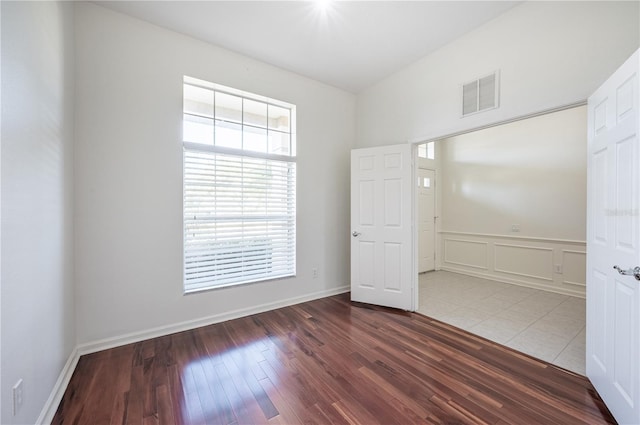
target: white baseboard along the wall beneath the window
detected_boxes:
[78,285,351,355]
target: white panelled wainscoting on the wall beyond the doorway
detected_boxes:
[438,231,587,298]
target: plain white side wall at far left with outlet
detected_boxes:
[0,2,76,424]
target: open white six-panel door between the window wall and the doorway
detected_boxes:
[351,144,417,311]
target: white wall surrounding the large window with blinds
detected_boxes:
[75,4,355,347]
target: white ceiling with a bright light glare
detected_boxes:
[95,1,520,93]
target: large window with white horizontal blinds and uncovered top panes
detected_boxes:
[183,77,296,292]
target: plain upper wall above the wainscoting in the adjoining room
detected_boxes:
[440,106,587,241]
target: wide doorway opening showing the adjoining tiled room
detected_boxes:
[417,105,587,374]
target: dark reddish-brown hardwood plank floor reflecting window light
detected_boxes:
[53,294,615,425]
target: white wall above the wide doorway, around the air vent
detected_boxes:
[357,2,640,147]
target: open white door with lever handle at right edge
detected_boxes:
[586,48,640,424]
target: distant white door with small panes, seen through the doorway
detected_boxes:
[418,168,436,273]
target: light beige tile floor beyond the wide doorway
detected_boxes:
[418,271,585,375]
